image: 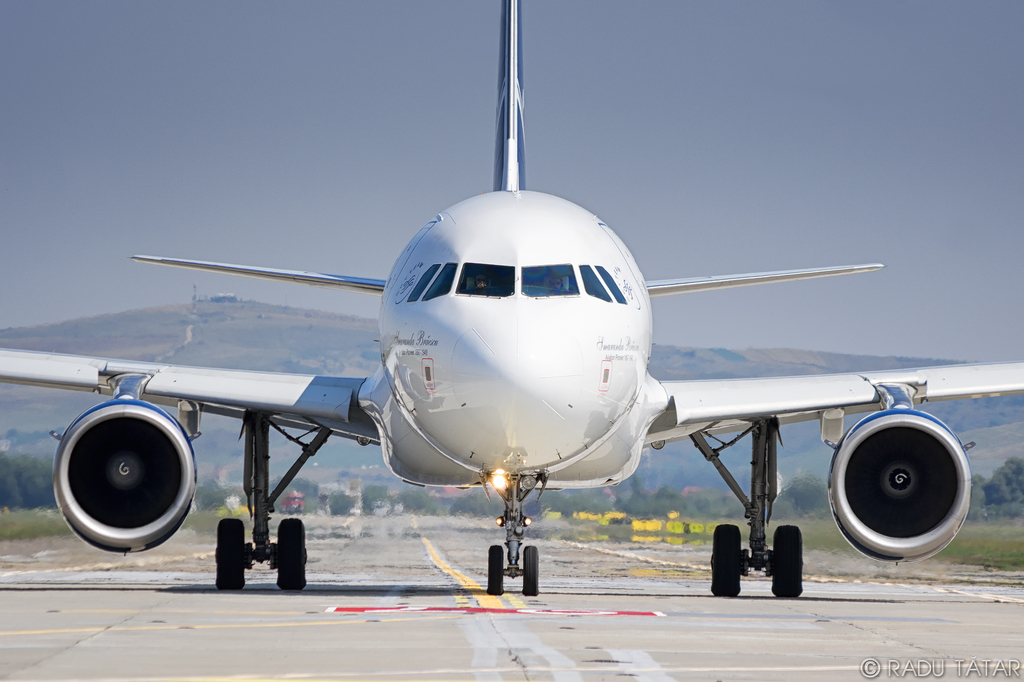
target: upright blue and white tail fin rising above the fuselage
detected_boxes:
[495,0,526,191]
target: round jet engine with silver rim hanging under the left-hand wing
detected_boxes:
[53,399,196,552]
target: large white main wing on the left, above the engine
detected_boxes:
[0,350,378,441]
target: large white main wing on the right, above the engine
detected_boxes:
[646,363,1024,442]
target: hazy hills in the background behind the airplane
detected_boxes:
[0,299,1024,487]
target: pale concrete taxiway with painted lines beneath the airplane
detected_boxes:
[0,517,1024,682]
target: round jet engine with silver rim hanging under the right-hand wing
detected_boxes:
[828,409,971,561]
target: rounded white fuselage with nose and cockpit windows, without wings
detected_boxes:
[359,191,666,487]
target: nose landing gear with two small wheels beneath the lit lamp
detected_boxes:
[484,469,546,597]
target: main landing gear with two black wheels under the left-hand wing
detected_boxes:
[217,413,331,590]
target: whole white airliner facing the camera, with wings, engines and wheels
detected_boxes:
[0,0,1024,597]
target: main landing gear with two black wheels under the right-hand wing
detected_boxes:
[690,419,804,597]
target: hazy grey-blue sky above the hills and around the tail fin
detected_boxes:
[0,0,1024,360]
